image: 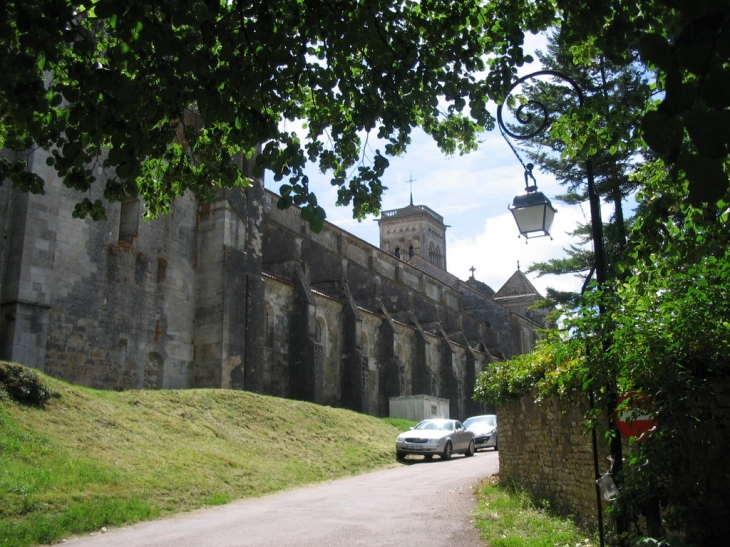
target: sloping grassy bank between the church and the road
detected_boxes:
[0,362,407,547]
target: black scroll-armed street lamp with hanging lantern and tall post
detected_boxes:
[497,70,622,547]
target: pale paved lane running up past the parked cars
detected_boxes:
[65,451,499,547]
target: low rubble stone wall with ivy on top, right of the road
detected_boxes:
[497,394,609,530]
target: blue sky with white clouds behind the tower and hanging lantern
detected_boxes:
[266,33,628,295]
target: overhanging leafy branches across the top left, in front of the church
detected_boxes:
[0,0,552,228]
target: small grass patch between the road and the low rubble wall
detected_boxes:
[475,476,597,547]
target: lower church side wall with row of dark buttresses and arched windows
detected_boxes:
[262,268,488,418]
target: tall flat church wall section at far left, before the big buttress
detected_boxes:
[0,150,196,389]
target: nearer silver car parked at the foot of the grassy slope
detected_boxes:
[395,419,476,460]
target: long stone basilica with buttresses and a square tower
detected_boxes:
[0,151,544,419]
